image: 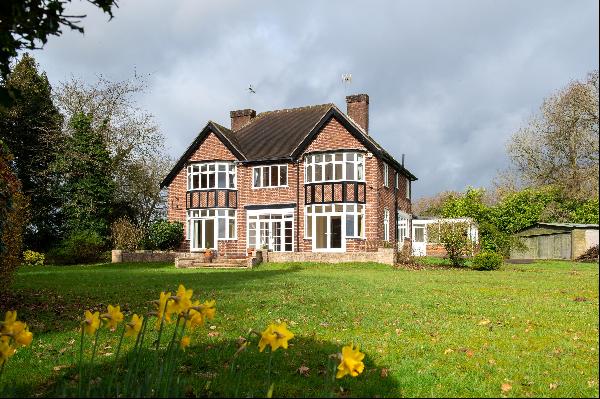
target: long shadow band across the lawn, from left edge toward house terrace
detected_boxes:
[5,264,303,333]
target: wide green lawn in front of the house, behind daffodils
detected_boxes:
[2,261,598,397]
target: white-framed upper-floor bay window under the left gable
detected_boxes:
[187,162,236,190]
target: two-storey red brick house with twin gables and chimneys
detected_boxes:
[161,94,417,258]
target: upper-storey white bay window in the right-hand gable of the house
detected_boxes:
[304,152,365,183]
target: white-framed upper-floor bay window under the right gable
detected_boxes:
[304,151,365,183]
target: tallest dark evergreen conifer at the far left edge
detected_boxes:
[0,54,63,250]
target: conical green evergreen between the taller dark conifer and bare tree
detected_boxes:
[56,113,115,238]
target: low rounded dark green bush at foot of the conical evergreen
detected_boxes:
[48,230,106,264]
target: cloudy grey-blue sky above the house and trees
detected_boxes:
[33,0,599,199]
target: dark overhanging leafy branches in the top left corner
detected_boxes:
[0,0,117,79]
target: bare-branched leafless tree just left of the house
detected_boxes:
[56,77,171,227]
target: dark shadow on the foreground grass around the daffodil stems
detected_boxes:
[3,333,400,397]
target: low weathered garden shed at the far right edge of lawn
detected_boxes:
[510,223,598,259]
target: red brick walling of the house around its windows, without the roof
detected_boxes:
[168,118,411,256]
